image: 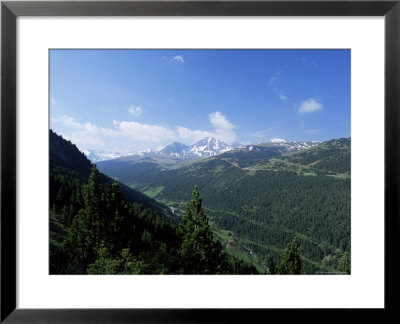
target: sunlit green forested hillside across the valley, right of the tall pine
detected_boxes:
[99,138,351,273]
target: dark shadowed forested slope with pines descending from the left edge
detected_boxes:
[49,130,258,274]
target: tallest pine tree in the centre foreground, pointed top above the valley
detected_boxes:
[181,186,227,274]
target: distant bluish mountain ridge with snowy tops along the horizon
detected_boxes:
[97,138,319,185]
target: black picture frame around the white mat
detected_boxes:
[0,0,400,323]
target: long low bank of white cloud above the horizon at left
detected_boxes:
[50,111,236,153]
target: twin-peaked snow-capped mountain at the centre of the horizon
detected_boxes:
[155,137,232,160]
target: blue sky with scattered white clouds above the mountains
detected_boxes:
[49,50,351,153]
